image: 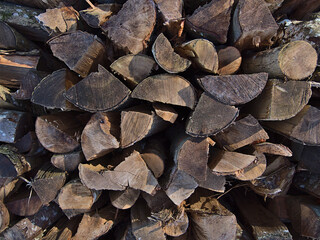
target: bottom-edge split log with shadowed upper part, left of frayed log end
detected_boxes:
[131,200,166,240]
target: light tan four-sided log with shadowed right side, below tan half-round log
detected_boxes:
[120,105,169,148]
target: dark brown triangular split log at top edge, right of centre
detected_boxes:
[186,0,234,44]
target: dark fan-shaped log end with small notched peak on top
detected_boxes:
[65,65,130,112]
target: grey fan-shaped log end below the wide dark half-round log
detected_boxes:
[186,93,239,137]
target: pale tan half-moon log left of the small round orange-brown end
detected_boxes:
[179,39,219,73]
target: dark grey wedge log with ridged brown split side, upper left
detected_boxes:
[48,31,105,77]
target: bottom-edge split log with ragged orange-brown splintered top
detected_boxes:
[189,195,237,240]
